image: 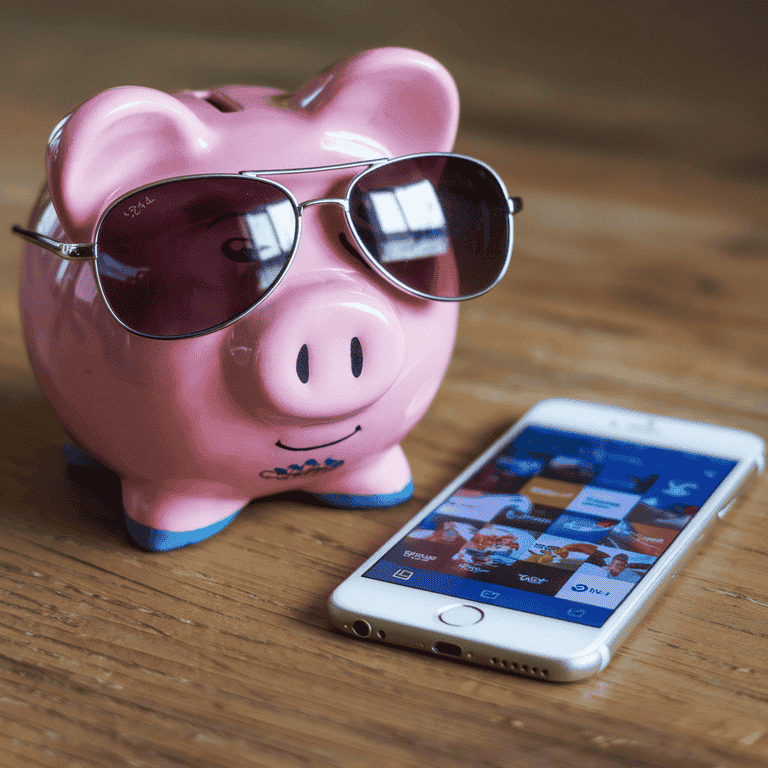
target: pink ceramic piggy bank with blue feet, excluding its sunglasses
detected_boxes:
[15,48,516,550]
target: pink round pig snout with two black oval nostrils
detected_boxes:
[232,284,405,420]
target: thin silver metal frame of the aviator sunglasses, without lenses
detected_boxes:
[12,152,523,341]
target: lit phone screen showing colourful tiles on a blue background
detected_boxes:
[363,426,736,627]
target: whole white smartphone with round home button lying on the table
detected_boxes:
[329,400,765,681]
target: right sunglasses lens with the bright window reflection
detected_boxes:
[350,155,512,299]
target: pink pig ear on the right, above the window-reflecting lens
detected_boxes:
[291,48,459,155]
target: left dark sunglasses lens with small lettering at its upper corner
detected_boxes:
[96,176,298,338]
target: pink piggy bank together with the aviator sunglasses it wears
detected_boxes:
[15,48,519,550]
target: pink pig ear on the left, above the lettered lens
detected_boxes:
[46,86,212,242]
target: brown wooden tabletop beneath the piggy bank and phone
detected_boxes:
[0,3,768,768]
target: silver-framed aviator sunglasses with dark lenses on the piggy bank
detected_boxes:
[13,153,522,339]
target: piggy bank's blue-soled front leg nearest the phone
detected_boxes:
[307,445,413,509]
